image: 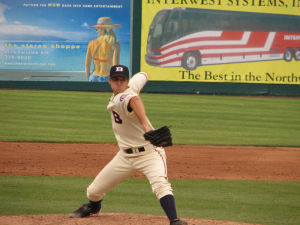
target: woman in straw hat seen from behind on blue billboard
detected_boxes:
[85,17,122,82]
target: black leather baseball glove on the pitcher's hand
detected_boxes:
[144,126,172,147]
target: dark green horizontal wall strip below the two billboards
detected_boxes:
[0,81,300,97]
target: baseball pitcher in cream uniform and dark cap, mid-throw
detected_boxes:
[70,65,187,225]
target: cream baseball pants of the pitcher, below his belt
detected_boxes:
[87,145,173,201]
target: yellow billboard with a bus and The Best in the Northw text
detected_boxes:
[140,0,300,84]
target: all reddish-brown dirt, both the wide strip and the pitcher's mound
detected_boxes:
[0,142,300,225]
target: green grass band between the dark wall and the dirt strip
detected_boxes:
[0,90,300,146]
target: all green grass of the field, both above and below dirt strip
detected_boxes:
[0,90,300,225]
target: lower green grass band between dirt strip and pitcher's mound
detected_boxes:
[0,176,300,225]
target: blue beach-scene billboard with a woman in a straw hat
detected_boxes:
[0,0,131,81]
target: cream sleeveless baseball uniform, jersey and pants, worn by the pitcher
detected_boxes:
[87,72,173,202]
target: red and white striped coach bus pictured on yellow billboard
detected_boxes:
[145,7,300,70]
